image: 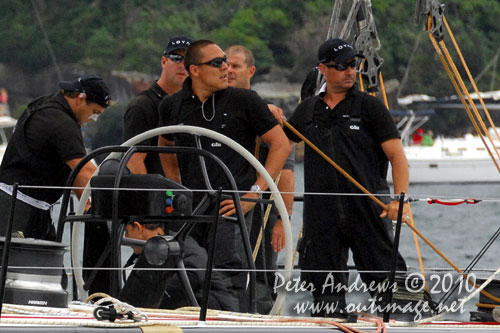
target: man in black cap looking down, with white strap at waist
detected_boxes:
[0,75,111,240]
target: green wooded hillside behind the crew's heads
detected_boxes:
[0,0,500,96]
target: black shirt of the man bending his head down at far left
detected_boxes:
[0,93,86,204]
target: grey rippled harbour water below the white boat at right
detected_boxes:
[280,164,500,320]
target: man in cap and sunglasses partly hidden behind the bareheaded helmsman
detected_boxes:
[123,36,193,174]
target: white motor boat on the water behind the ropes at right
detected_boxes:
[387,91,500,184]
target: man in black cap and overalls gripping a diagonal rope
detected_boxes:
[285,39,409,316]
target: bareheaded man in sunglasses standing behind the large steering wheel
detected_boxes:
[159,40,291,311]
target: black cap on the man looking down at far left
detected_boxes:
[59,74,111,108]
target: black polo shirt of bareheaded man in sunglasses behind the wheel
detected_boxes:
[159,78,278,195]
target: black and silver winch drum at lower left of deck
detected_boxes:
[0,237,68,307]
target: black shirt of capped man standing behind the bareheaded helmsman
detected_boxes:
[123,82,167,174]
